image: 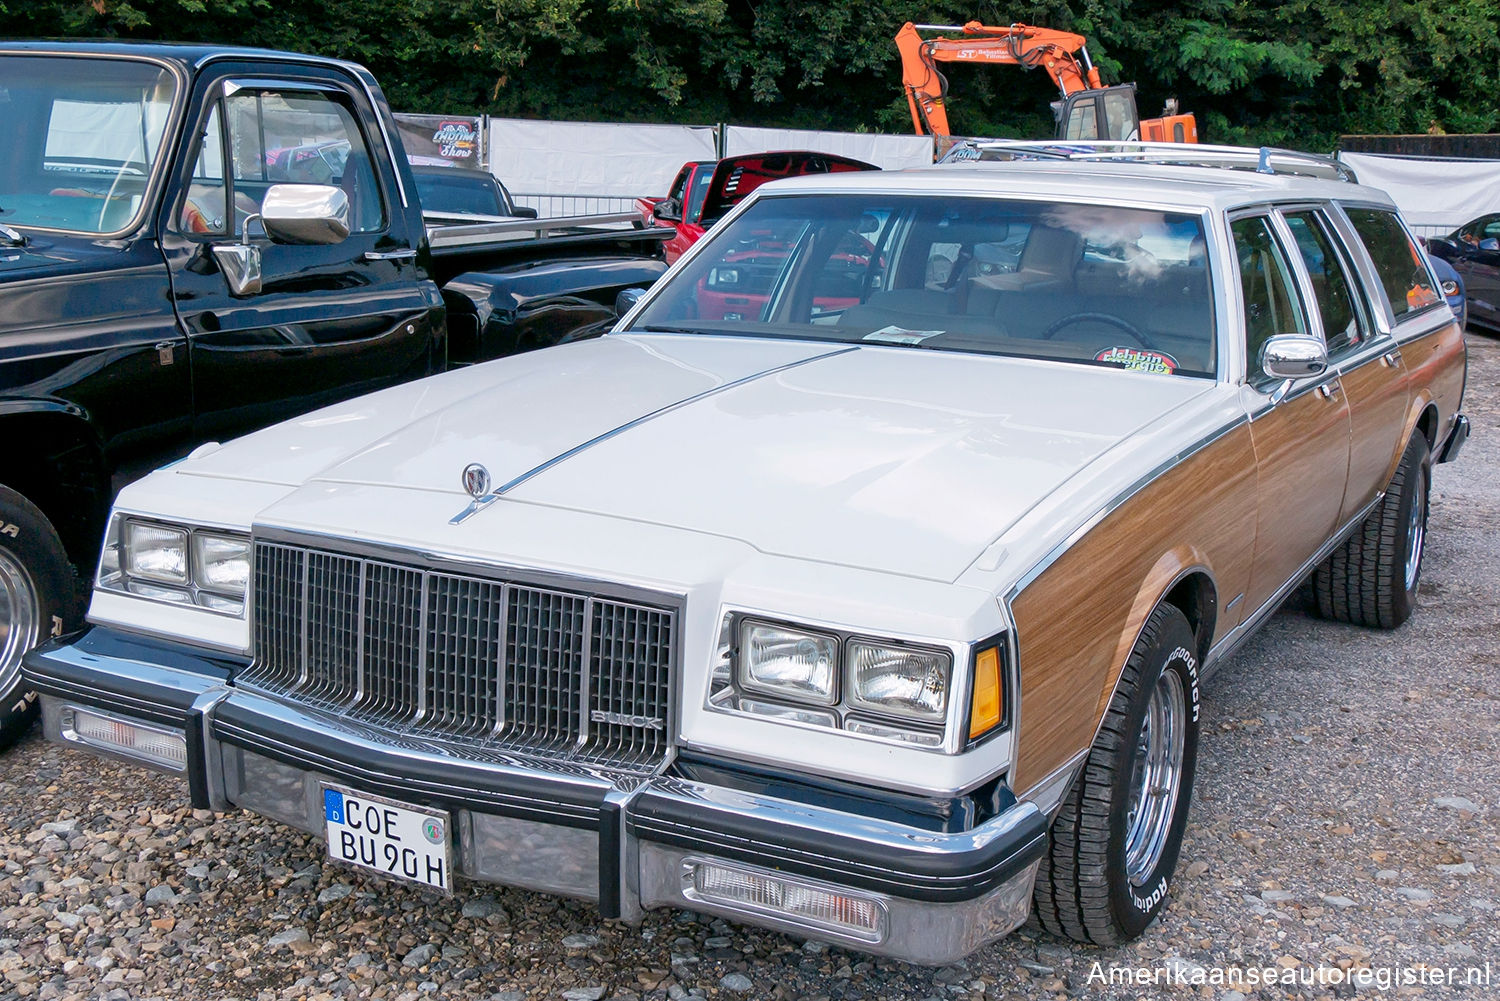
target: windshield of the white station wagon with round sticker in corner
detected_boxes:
[633,194,1215,377]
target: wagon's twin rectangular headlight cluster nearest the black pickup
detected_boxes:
[98,515,251,617]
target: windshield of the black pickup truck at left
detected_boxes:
[0,56,176,233]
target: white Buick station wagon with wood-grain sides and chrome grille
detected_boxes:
[26,144,1469,963]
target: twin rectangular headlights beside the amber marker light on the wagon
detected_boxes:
[710,617,998,749]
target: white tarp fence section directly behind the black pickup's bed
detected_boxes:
[489,119,716,203]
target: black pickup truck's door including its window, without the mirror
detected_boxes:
[162,65,444,438]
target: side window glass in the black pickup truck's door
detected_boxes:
[224,90,386,233]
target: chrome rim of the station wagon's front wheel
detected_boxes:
[1125,671,1188,887]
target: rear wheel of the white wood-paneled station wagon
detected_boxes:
[1313,434,1433,629]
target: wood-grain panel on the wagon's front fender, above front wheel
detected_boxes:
[1011,425,1256,791]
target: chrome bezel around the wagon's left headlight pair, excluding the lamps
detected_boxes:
[95,512,252,620]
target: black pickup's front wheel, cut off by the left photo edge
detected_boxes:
[0,486,78,750]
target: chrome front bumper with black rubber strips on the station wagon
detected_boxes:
[26,629,1047,965]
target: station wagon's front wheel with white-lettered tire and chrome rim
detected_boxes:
[1035,605,1199,945]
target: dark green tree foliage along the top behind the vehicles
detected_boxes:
[0,0,1500,150]
